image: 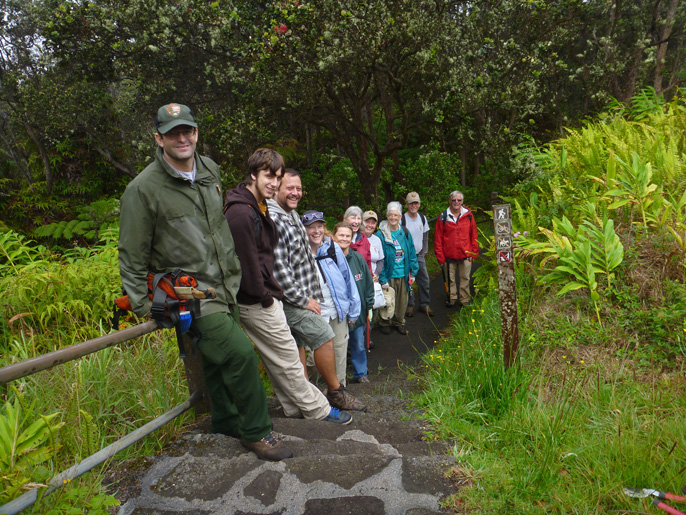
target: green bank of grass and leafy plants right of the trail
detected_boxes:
[418,95,686,514]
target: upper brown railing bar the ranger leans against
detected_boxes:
[0,320,160,384]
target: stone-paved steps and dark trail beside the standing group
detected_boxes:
[112,274,472,515]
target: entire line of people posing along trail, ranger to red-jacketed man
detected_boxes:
[119,104,478,461]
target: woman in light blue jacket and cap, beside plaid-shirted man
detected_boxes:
[302,211,360,386]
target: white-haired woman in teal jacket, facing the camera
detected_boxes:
[376,202,419,334]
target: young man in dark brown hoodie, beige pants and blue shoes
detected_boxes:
[224,148,352,424]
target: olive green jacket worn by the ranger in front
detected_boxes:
[119,148,241,317]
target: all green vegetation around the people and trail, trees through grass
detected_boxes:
[0,0,686,514]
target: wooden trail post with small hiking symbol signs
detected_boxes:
[493,204,519,368]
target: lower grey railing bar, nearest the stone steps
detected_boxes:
[0,392,202,515]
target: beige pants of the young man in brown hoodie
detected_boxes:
[239,300,331,420]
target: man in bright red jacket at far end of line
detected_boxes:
[434,191,479,307]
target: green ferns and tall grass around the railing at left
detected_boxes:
[0,231,189,513]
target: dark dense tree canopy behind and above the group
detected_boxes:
[0,0,686,228]
